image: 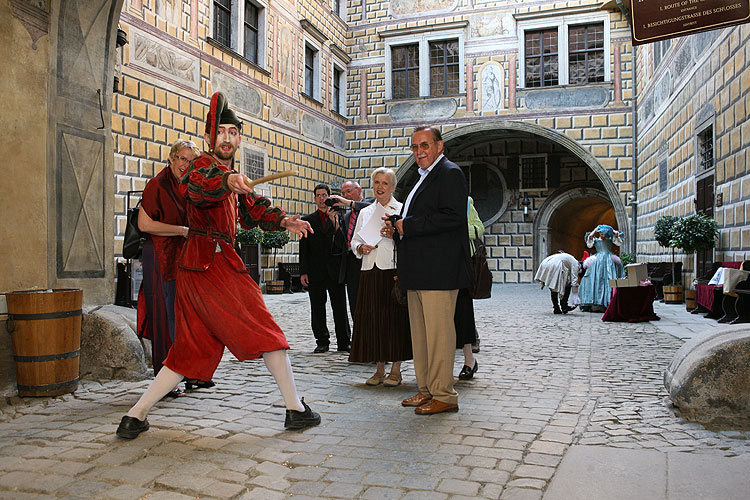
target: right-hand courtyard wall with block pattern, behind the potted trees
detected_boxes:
[637,24,750,283]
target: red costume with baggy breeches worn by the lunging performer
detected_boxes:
[164,153,289,380]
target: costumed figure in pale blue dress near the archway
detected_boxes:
[579,224,625,312]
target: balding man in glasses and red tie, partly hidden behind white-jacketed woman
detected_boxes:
[331,181,373,318]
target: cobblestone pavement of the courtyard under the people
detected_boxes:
[0,285,750,500]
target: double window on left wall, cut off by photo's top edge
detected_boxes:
[212,0,266,67]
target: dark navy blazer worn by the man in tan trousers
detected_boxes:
[396,157,474,290]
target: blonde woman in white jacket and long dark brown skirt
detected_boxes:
[349,167,412,387]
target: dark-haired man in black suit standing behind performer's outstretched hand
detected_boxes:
[299,184,351,354]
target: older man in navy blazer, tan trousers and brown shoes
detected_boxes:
[394,127,474,415]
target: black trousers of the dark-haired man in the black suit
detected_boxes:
[307,279,352,349]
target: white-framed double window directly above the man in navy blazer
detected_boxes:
[381,29,466,99]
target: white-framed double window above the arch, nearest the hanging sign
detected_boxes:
[518,13,611,88]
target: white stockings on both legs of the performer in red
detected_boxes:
[128,349,303,420]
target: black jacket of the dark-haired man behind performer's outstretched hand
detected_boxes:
[299,210,342,283]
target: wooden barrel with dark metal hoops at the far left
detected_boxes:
[6,289,83,396]
